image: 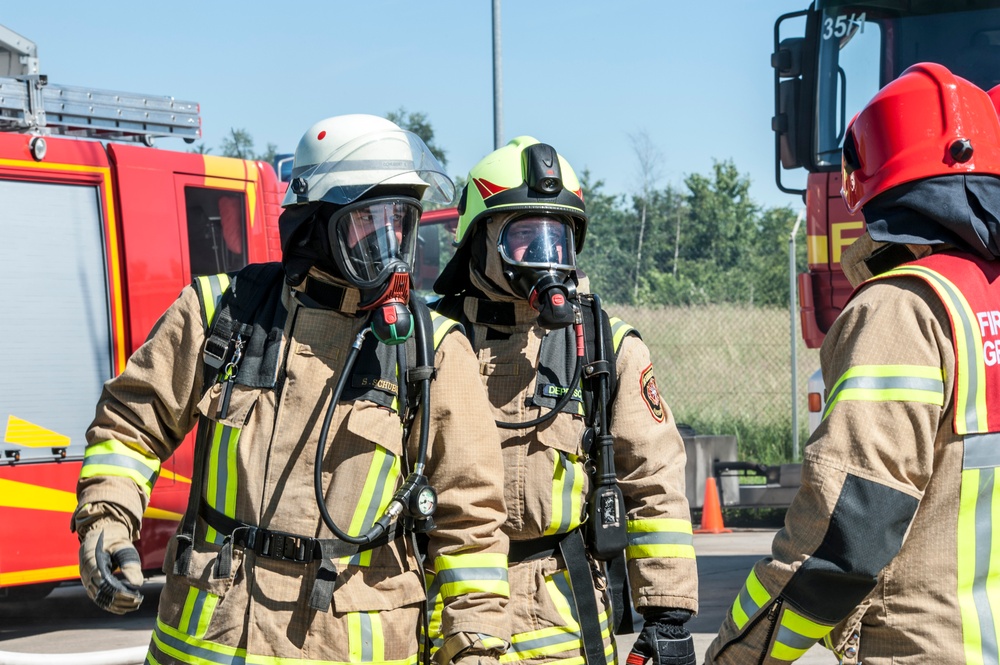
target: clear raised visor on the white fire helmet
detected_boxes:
[281,129,455,207]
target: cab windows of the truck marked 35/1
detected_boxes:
[815,0,1000,168]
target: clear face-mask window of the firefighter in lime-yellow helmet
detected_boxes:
[498,215,576,270]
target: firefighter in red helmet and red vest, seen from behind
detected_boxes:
[707,63,1000,665]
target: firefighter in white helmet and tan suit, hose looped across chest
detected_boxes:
[74,115,509,665]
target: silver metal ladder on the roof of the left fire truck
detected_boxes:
[0,26,201,145]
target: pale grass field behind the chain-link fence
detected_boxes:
[605,304,819,464]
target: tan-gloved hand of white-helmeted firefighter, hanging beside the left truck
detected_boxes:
[80,517,142,614]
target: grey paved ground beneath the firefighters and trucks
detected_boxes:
[0,531,835,665]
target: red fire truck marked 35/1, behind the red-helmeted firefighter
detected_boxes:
[771,0,1000,424]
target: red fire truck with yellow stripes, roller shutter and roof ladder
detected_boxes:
[0,27,281,597]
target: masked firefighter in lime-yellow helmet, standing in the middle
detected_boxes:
[431,136,698,665]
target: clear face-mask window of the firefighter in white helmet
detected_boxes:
[330,198,420,288]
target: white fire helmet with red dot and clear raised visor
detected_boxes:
[281,114,455,208]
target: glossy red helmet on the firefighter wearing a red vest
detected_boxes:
[841,62,1000,213]
